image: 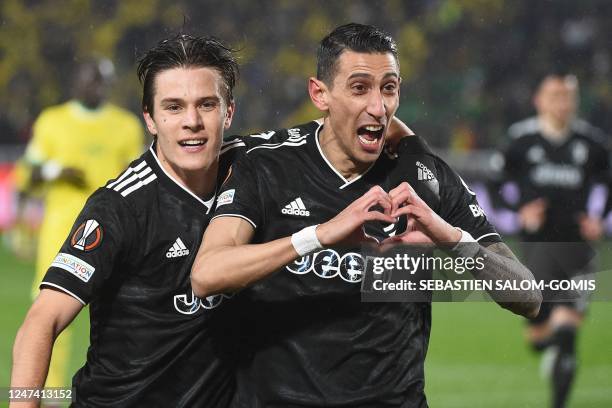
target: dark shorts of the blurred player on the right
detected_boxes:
[522,242,596,325]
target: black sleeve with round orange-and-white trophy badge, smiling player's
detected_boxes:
[40,189,134,305]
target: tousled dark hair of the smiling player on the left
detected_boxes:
[137,34,239,114]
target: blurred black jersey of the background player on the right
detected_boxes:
[505,118,610,242]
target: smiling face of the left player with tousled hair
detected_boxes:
[144,67,234,180]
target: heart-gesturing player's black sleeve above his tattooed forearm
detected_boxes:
[438,162,501,243]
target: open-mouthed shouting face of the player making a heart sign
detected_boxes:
[328,51,400,163]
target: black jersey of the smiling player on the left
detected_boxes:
[41,135,282,407]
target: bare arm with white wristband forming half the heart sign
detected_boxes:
[191,185,394,297]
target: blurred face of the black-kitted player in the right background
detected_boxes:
[535,78,577,125]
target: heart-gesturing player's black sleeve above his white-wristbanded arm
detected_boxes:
[213,154,264,229]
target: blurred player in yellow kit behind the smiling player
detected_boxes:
[20,59,143,387]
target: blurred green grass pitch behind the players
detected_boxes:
[0,243,612,408]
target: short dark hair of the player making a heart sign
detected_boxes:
[317,23,399,85]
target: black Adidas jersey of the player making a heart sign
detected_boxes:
[215,122,499,407]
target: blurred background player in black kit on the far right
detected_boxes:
[505,74,610,407]
